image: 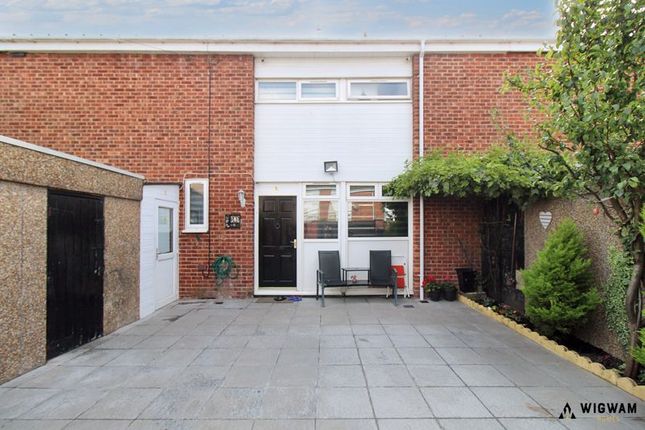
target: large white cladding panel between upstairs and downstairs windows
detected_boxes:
[255,102,412,182]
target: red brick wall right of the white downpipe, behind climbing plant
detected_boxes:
[414,53,539,286]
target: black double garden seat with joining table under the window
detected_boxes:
[316,251,397,307]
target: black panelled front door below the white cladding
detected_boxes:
[260,196,296,287]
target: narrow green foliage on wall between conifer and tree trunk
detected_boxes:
[602,248,634,351]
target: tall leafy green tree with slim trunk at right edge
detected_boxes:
[508,0,645,377]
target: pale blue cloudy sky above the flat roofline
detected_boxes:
[0,0,555,39]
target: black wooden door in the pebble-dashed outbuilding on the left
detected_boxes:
[47,191,104,358]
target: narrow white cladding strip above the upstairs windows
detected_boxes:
[255,57,412,79]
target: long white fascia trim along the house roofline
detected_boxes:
[0,39,553,55]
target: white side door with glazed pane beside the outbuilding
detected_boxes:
[140,185,179,317]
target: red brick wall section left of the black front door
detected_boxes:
[0,54,254,297]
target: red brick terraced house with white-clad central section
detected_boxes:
[0,40,542,316]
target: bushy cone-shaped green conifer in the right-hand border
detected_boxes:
[523,219,600,336]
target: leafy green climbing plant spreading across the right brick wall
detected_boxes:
[386,140,563,207]
